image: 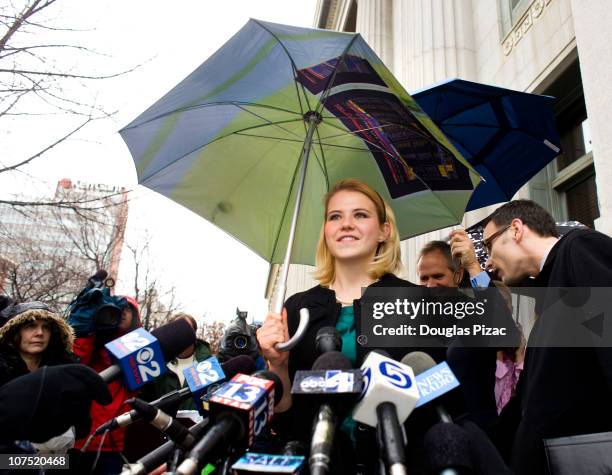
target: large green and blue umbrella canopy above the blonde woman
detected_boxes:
[120,20,480,264]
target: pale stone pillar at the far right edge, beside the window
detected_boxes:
[571,0,612,235]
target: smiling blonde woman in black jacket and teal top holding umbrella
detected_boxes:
[257,179,415,412]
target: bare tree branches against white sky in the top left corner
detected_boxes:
[0,0,141,180]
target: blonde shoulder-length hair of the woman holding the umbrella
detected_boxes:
[314,178,402,287]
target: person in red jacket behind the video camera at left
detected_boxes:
[73,296,142,475]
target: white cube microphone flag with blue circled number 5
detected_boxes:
[353,351,419,427]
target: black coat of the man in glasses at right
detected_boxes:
[513,230,612,474]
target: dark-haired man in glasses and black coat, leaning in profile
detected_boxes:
[483,200,612,474]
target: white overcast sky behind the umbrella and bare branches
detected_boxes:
[0,0,316,319]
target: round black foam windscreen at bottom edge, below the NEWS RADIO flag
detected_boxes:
[423,422,473,473]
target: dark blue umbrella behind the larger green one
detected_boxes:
[412,79,560,211]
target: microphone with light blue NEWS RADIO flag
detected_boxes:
[402,351,459,422]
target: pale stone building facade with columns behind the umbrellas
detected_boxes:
[269,0,612,304]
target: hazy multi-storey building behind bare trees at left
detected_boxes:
[0,178,127,310]
